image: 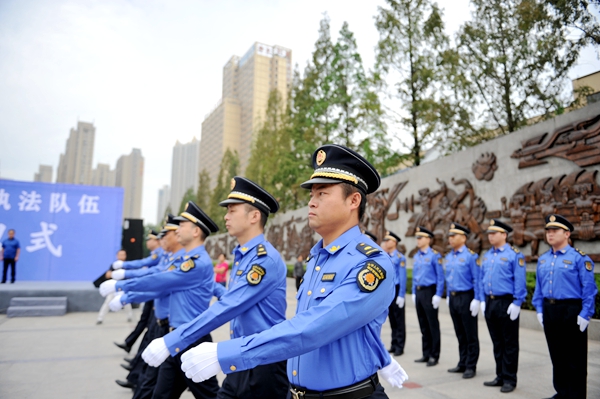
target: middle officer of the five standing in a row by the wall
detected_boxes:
[444,223,481,378]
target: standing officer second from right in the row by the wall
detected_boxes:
[480,219,527,393]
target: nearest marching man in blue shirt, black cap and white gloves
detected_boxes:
[172,144,408,398]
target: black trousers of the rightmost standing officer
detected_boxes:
[543,299,587,399]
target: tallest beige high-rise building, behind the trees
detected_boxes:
[199,42,292,188]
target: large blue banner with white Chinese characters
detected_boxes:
[0,180,123,281]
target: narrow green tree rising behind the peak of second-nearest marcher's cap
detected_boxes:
[207,148,240,232]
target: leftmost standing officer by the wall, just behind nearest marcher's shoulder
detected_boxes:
[381,231,406,356]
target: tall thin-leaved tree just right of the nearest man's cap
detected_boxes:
[375,0,448,165]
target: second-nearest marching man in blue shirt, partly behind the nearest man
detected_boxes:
[142,176,289,399]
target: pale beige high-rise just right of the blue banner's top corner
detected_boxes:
[115,148,144,219]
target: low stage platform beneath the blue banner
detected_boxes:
[0,281,104,314]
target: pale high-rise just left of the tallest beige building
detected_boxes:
[170,137,201,214]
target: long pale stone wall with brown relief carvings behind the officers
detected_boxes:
[207,103,600,269]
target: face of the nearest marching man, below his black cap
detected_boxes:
[308,184,360,236]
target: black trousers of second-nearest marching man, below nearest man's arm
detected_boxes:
[217,360,290,399]
